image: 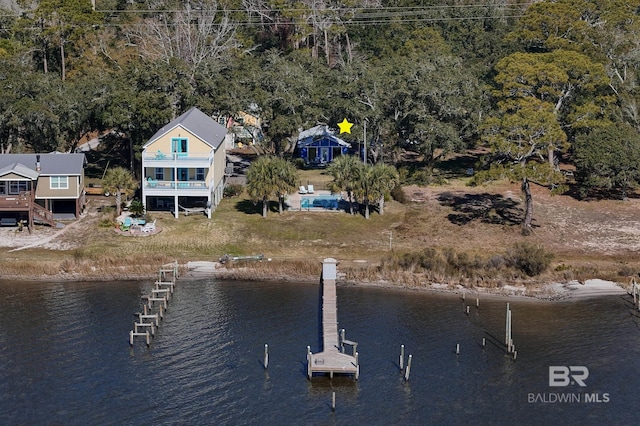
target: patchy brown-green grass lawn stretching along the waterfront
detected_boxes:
[0,162,640,282]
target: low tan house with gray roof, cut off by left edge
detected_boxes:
[0,153,85,229]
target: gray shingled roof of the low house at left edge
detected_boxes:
[0,153,85,178]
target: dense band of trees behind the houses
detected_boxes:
[0,0,640,210]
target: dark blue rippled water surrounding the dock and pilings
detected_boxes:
[0,280,640,425]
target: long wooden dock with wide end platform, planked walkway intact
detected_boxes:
[307,258,360,380]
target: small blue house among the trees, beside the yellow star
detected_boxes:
[296,125,351,167]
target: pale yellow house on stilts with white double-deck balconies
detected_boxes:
[142,107,227,219]
